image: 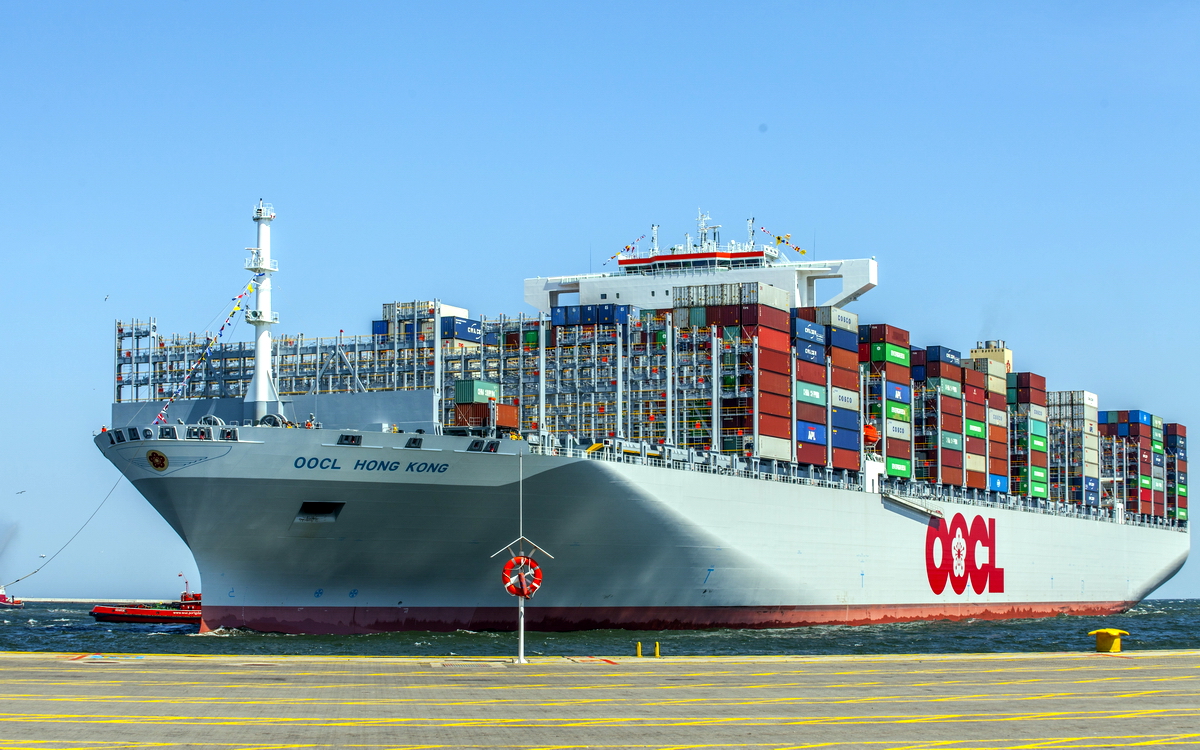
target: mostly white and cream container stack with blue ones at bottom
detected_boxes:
[1046,391,1099,506]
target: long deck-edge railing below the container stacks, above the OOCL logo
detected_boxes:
[529,445,1187,532]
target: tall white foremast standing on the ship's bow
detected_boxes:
[246,198,280,425]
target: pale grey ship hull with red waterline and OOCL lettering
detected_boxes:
[97,427,1190,634]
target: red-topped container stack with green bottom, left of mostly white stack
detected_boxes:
[1007,372,1050,499]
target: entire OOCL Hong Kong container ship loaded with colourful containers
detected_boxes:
[95,202,1190,634]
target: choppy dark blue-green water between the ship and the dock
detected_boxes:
[0,599,1200,656]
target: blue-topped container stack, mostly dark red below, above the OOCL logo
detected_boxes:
[911,347,965,487]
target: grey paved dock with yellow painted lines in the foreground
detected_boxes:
[0,650,1200,750]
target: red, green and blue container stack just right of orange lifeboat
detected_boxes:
[858,324,913,479]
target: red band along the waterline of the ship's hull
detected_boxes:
[200,601,1136,634]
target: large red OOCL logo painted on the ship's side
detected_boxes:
[925,514,1004,594]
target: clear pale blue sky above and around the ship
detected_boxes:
[0,1,1200,598]
